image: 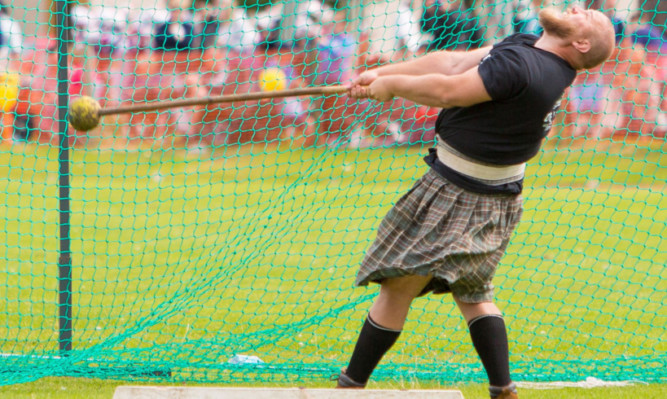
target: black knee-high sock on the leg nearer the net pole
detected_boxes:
[345,314,401,384]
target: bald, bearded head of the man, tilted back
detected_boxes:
[539,7,615,69]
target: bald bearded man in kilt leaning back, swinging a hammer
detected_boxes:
[338,7,614,398]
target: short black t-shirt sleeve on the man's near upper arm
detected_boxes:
[478,49,528,101]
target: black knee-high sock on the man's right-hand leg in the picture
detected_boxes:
[468,315,512,387]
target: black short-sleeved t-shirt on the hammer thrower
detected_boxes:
[427,33,576,193]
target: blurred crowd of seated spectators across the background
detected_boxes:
[0,0,667,149]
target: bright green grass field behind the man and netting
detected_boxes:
[0,138,667,398]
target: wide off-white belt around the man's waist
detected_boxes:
[436,140,526,184]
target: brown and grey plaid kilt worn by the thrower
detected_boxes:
[355,169,523,303]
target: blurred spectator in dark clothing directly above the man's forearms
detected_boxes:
[421,0,483,51]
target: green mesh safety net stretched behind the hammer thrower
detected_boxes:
[0,0,667,390]
